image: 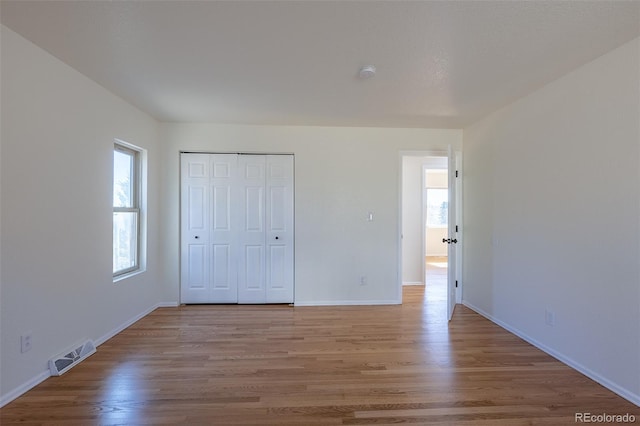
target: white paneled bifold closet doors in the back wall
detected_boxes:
[181,154,294,303]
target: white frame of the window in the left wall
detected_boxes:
[111,139,146,282]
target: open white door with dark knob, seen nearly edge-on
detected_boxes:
[447,145,458,321]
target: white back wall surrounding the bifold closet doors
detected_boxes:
[161,124,462,305]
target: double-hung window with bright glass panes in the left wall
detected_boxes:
[113,143,141,277]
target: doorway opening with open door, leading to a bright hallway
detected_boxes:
[398,150,462,321]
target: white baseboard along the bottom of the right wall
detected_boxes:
[462,300,640,407]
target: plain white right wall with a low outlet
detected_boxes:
[464,39,640,404]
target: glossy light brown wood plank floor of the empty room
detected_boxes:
[0,287,640,426]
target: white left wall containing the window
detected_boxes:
[0,26,161,405]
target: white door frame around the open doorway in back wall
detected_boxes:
[397,150,463,304]
